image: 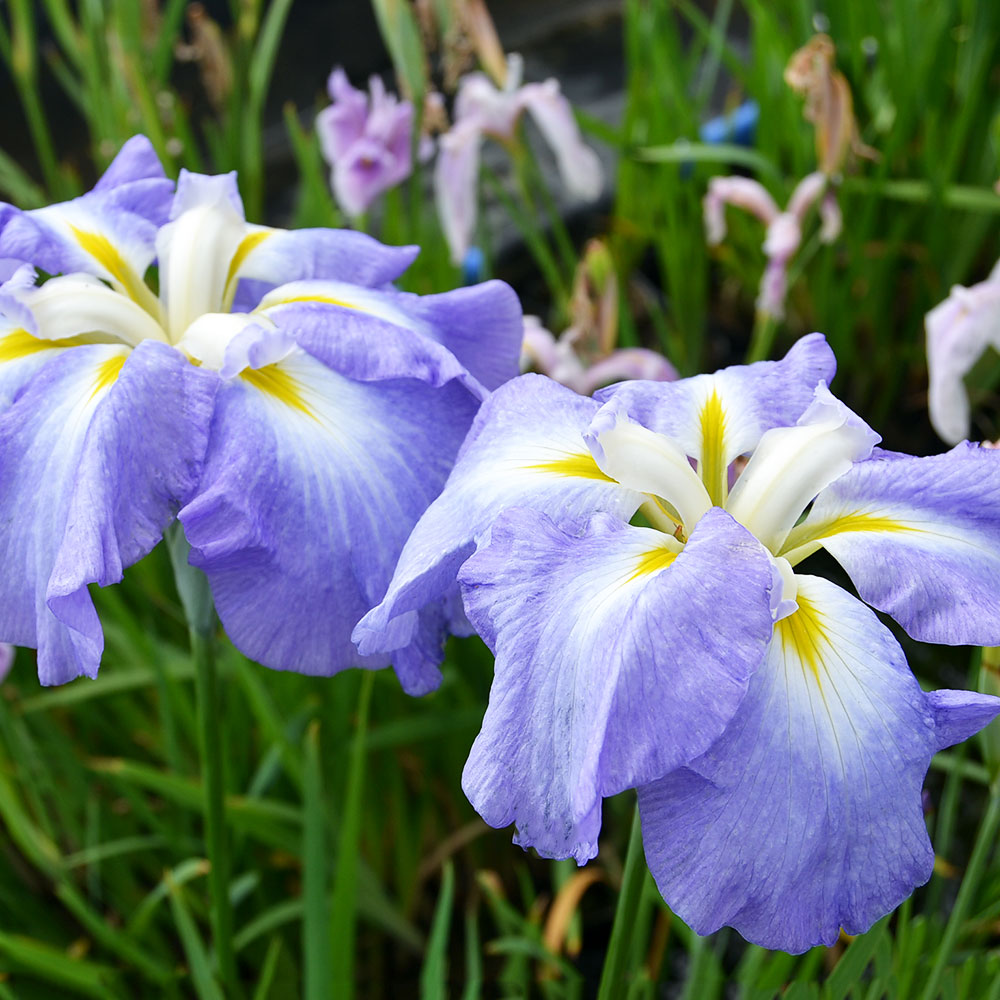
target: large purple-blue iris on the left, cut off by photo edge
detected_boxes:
[0,137,521,691]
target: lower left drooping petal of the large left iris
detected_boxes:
[0,343,217,684]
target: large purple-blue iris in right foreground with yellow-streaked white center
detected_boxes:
[355,334,1000,952]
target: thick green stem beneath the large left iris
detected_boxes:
[167,525,240,997]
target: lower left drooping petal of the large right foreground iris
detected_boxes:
[459,508,771,864]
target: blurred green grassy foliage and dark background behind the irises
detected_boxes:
[0,0,1000,1000]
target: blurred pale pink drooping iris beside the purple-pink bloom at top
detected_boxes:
[434,54,604,264]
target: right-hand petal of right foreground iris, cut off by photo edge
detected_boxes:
[782,442,1000,645]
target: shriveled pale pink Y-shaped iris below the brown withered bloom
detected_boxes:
[704,171,843,320]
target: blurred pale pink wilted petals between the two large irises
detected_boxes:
[521,316,678,396]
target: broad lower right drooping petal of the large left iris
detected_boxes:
[179,335,477,687]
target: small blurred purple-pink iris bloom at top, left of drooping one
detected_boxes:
[316,67,430,218]
